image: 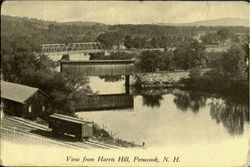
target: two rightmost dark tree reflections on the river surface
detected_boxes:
[174,90,249,135]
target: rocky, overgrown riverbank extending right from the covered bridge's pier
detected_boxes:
[132,69,249,102]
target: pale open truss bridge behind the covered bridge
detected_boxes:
[42,42,104,55]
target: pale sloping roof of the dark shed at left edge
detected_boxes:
[1,81,39,103]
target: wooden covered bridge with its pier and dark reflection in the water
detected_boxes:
[61,60,134,111]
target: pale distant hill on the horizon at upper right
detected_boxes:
[160,18,249,27]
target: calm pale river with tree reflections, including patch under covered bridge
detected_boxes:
[77,77,249,147]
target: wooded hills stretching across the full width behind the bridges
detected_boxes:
[1,16,249,54]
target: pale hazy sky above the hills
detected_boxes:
[1,1,249,24]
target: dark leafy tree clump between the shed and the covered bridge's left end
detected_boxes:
[2,53,91,115]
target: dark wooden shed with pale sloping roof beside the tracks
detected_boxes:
[1,81,49,119]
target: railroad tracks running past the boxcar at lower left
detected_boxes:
[1,116,119,149]
